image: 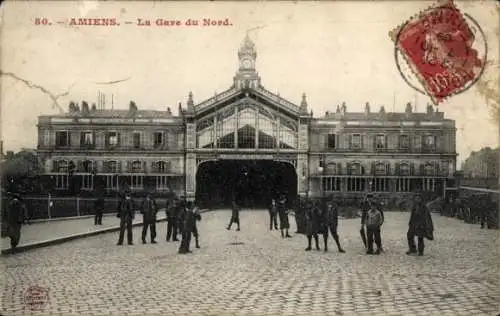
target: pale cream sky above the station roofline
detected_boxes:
[0,1,500,166]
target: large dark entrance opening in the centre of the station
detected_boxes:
[196,160,297,208]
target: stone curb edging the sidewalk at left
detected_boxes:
[2,209,210,255]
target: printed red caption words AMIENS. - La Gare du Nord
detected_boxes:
[63,18,233,26]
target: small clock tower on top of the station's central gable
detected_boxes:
[234,34,260,89]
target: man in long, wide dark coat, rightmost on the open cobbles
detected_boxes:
[406,195,434,256]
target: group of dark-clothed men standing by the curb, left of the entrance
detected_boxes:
[117,190,201,254]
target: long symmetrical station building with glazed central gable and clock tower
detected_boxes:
[38,37,457,204]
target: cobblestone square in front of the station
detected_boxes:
[0,211,500,315]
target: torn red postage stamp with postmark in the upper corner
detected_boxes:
[390,0,485,104]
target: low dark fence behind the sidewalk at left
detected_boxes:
[1,195,172,219]
